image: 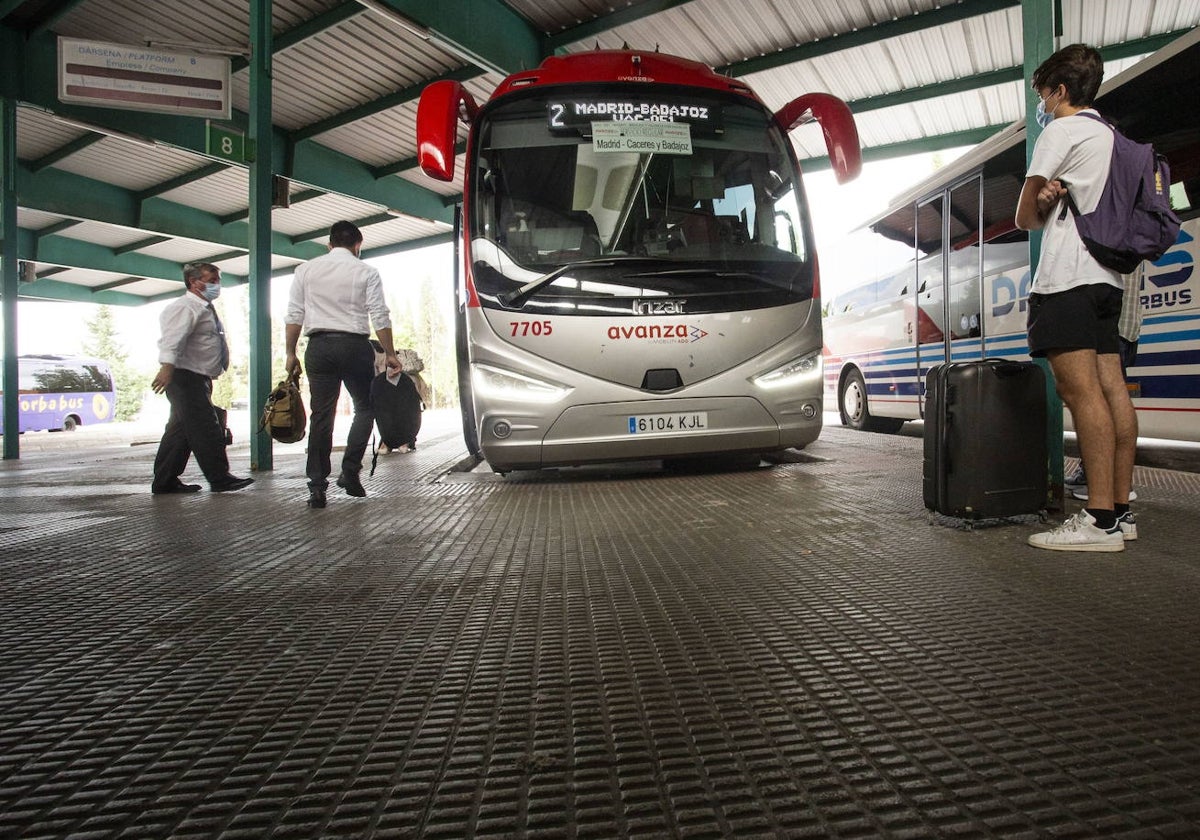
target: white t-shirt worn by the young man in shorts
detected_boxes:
[1028,109,1122,294]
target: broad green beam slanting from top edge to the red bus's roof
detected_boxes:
[360,0,544,76]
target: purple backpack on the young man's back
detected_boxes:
[1058,112,1180,274]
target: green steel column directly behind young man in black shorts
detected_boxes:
[1014,0,1063,510]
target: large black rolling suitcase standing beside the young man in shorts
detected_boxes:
[923,359,1048,520]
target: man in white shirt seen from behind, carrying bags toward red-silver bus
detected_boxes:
[284,222,401,508]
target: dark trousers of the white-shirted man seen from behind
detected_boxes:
[304,332,374,490]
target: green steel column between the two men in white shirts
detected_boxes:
[250,0,274,470]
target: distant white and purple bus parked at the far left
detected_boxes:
[0,355,116,434]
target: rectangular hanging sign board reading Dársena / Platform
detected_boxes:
[59,38,233,120]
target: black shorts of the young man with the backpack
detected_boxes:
[1028,283,1124,356]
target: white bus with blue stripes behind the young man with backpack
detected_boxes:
[823,29,1200,440]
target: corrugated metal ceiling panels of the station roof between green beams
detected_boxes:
[2,0,1200,302]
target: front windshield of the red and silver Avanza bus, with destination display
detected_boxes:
[468,85,814,314]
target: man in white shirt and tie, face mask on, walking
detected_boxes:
[150,263,254,496]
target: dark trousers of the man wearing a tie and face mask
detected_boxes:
[151,367,229,490]
